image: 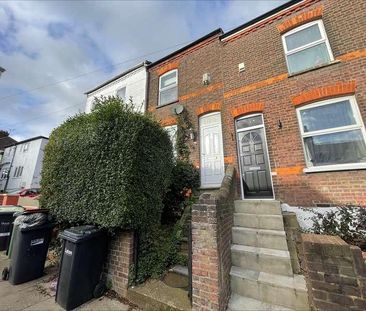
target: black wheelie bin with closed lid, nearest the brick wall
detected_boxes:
[56,226,107,310]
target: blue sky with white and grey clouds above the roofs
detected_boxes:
[0,0,288,140]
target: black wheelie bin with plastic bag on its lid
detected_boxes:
[8,212,54,285]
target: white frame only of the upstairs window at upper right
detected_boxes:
[282,19,334,75]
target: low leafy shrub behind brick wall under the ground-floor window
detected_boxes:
[309,205,366,250]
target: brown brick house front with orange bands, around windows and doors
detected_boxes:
[148,0,366,206]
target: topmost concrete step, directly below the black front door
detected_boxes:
[235,200,281,215]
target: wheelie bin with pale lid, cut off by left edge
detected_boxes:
[0,205,23,251]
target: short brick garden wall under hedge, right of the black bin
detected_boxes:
[104,231,134,297]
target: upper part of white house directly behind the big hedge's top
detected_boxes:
[85,61,150,113]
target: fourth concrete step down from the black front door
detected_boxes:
[231,244,293,276]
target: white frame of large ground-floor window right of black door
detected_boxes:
[296,96,366,173]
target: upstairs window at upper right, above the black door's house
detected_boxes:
[282,20,334,74]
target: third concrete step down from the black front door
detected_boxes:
[232,227,288,251]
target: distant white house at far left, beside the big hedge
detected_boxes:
[0,136,48,192]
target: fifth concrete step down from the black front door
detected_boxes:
[230,266,309,310]
